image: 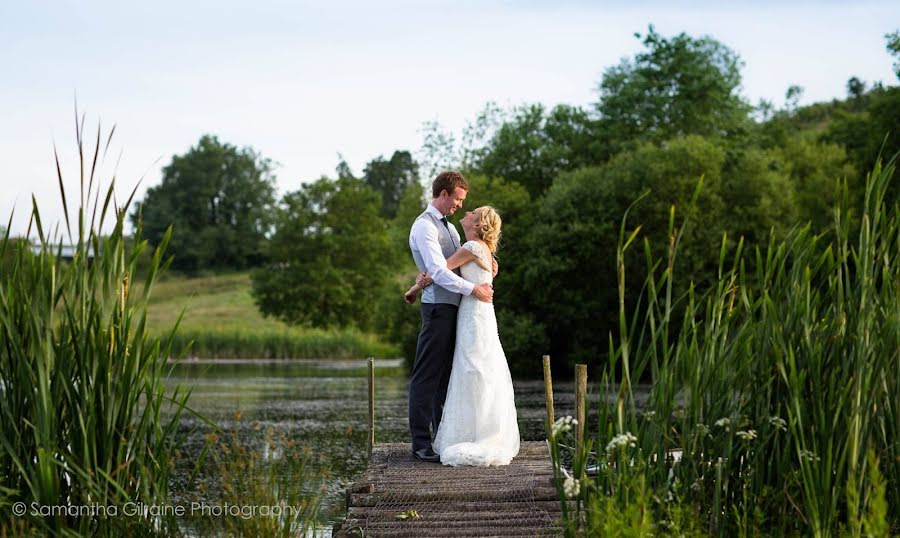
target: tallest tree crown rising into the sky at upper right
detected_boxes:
[597,26,750,156]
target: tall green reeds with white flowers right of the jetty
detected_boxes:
[551,157,900,536]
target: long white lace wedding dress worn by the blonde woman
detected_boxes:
[433,241,519,467]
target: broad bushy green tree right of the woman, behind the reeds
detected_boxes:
[518,136,793,362]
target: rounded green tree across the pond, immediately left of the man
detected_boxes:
[253,178,392,329]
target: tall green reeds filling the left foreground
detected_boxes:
[0,111,188,536]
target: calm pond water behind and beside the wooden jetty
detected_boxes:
[167,360,588,522]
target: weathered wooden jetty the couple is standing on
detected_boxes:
[333,441,562,537]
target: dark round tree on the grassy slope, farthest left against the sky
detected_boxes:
[131,135,275,272]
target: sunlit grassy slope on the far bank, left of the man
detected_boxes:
[149,273,399,358]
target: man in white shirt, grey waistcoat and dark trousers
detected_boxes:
[409,172,494,462]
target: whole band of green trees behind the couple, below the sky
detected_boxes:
[131,26,900,374]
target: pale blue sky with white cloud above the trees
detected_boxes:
[0,0,900,235]
